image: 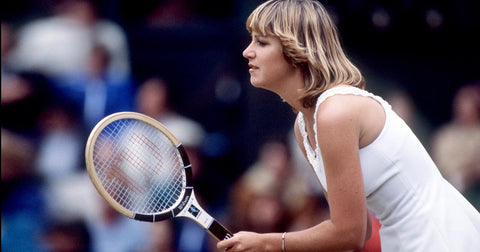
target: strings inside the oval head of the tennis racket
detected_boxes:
[94,119,185,213]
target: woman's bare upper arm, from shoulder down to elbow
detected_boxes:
[317,96,367,235]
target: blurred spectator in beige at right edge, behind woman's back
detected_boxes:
[432,84,480,192]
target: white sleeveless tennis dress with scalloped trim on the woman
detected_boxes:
[298,86,480,252]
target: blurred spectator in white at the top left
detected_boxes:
[13,0,130,78]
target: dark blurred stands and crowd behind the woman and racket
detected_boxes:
[1,0,480,252]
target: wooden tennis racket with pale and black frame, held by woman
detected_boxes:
[85,112,233,241]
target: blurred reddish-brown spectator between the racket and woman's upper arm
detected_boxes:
[231,140,310,232]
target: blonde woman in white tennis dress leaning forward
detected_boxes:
[217,0,480,252]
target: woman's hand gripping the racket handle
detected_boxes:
[217,231,267,252]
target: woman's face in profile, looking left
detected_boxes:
[243,33,295,91]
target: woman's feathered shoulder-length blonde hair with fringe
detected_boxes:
[246,0,365,108]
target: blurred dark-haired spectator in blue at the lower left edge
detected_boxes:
[1,129,46,252]
